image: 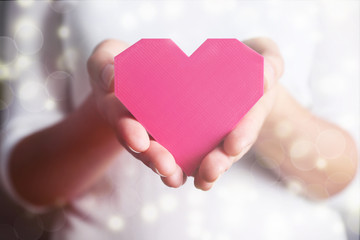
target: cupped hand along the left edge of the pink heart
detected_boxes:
[87,40,186,187]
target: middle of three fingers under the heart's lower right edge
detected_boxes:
[199,147,232,183]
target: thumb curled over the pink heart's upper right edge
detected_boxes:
[243,37,284,92]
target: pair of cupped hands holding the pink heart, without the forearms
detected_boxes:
[88,38,283,190]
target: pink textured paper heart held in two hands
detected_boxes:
[114,39,263,175]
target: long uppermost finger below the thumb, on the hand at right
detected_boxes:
[223,88,276,157]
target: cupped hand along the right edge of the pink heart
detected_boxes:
[194,37,284,190]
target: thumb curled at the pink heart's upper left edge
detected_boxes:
[87,40,128,93]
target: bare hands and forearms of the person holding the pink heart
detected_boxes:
[10,38,358,206]
